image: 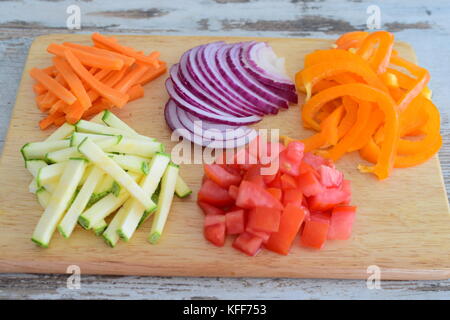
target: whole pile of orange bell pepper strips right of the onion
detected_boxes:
[285,31,442,179]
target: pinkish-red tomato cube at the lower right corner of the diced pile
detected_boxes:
[328,206,356,240]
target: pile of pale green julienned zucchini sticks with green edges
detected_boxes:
[21,111,191,247]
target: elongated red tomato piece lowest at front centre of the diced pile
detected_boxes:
[265,204,306,255]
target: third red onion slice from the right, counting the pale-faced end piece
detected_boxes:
[216,45,279,114]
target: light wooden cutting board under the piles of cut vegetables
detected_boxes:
[0,34,450,279]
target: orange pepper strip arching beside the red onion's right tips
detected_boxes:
[295,55,388,100]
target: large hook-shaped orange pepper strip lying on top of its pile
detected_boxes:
[302,83,399,179]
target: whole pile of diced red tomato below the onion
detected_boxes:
[197,137,356,256]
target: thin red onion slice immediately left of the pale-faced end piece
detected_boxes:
[226,44,289,108]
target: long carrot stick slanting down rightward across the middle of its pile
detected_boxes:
[64,50,128,107]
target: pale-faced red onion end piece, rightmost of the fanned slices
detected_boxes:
[241,42,295,92]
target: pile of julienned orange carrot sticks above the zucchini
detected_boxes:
[30,33,166,130]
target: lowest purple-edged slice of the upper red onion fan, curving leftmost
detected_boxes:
[166,78,261,125]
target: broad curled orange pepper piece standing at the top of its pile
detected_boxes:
[356,31,394,74]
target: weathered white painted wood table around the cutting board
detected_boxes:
[0,0,450,299]
